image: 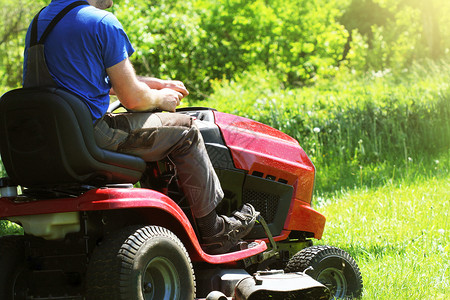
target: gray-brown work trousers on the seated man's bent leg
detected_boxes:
[94,113,223,218]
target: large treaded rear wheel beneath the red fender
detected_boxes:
[86,226,195,300]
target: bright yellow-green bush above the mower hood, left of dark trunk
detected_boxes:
[195,0,346,85]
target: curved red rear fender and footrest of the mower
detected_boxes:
[0,188,267,264]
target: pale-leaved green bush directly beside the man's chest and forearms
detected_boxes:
[112,0,208,98]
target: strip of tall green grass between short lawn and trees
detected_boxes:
[203,62,450,192]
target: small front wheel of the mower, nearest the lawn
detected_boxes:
[285,246,363,299]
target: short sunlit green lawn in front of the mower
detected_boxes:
[318,174,450,299]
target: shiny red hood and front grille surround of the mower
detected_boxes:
[214,112,325,239]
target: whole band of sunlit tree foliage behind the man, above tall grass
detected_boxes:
[0,0,450,99]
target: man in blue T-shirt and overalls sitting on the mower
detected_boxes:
[24,0,257,254]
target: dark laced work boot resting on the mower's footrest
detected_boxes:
[202,203,259,254]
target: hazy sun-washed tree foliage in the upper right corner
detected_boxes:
[339,0,450,70]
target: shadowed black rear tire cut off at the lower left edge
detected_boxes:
[0,235,26,300]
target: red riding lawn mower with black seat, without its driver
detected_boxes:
[0,88,362,300]
